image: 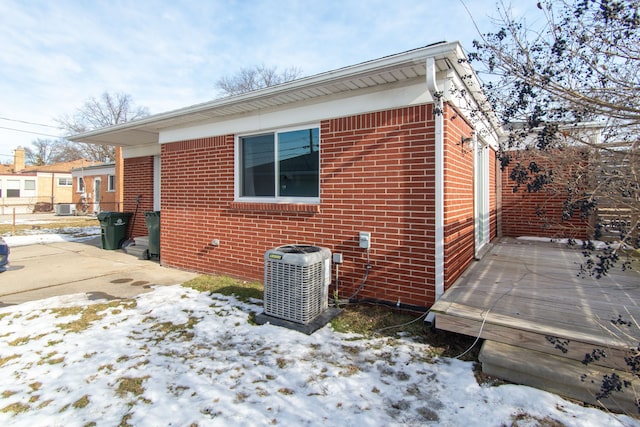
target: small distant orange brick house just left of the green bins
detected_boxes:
[71,163,120,214]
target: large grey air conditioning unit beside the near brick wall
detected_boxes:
[264,245,331,325]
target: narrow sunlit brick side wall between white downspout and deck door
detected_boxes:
[444,105,475,289]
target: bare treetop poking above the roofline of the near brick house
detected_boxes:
[216,65,302,95]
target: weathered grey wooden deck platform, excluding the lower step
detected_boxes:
[431,239,640,366]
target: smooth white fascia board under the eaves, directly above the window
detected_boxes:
[158,78,433,148]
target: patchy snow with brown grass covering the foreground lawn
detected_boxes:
[0,285,640,427]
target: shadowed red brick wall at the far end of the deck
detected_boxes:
[501,159,588,239]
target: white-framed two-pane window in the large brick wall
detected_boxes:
[236,126,320,203]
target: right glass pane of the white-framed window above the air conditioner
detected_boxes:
[278,128,320,197]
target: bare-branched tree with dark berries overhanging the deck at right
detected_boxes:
[469,0,640,276]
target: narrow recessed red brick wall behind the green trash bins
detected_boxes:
[123,156,153,237]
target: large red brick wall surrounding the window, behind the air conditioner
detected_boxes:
[160,105,440,307]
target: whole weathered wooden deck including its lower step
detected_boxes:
[431,238,640,413]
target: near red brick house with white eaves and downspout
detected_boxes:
[71,43,500,308]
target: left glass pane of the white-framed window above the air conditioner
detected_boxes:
[240,134,275,197]
